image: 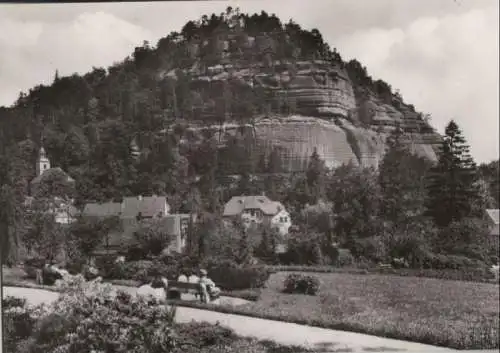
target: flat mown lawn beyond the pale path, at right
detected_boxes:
[229,273,499,349]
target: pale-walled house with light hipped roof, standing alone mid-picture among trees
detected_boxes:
[223,195,292,235]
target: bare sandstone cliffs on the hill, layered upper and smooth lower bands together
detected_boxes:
[167,51,439,171]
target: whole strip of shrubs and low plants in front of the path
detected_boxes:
[3,277,310,353]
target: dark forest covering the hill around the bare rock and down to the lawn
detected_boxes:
[0,8,499,266]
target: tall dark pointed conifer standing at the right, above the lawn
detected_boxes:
[427,120,479,227]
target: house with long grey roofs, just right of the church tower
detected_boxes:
[82,196,196,255]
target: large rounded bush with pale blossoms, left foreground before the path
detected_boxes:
[21,276,175,353]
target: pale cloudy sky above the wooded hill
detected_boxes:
[0,0,499,163]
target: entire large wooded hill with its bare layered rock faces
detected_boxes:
[0,8,440,200]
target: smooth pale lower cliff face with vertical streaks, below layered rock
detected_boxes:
[178,115,439,172]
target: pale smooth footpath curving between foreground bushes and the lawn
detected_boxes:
[3,287,482,353]
